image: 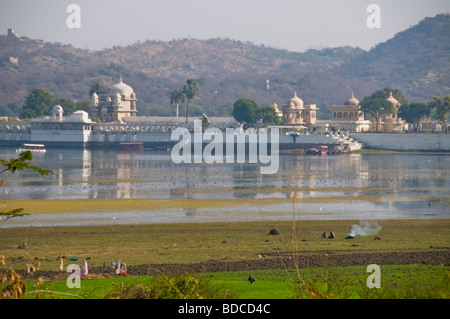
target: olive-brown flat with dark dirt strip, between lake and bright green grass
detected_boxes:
[0,219,450,276]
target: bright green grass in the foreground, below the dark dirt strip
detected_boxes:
[26,265,450,299]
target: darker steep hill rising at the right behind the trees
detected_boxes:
[334,14,450,100]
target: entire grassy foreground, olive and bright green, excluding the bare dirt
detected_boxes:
[0,219,450,299]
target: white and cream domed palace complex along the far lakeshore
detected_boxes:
[0,78,424,148]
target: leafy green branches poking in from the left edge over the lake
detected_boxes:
[0,151,53,222]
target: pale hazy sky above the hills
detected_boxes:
[0,0,450,52]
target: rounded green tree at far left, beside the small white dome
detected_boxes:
[20,89,55,118]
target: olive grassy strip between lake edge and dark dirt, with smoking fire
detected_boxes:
[0,219,450,271]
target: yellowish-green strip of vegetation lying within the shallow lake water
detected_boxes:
[0,189,450,214]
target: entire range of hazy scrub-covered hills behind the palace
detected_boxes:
[0,14,450,119]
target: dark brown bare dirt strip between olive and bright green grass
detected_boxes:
[20,249,450,280]
